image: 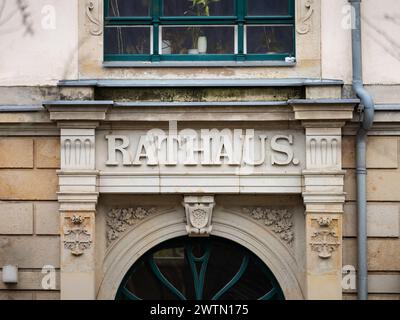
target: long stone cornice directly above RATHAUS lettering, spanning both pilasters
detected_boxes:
[43,99,359,124]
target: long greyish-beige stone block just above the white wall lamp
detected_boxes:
[0,236,60,268]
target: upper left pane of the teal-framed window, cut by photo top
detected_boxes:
[108,0,151,17]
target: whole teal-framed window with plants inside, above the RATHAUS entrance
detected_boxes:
[104,0,295,62]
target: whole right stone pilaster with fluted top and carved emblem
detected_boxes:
[290,99,358,300]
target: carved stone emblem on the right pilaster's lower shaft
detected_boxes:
[310,216,340,259]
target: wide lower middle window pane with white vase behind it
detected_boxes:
[162,26,235,54]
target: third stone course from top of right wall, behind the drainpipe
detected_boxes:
[343,202,400,237]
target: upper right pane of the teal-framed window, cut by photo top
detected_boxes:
[247,0,289,16]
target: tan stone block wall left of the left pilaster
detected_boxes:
[0,136,60,300]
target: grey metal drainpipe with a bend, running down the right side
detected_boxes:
[349,0,375,300]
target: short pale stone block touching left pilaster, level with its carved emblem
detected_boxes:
[35,201,60,235]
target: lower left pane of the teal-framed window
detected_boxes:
[104,27,151,54]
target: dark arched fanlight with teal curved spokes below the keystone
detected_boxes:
[116,236,284,300]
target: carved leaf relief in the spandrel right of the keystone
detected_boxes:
[243,207,294,246]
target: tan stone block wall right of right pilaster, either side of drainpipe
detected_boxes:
[343,133,400,300]
